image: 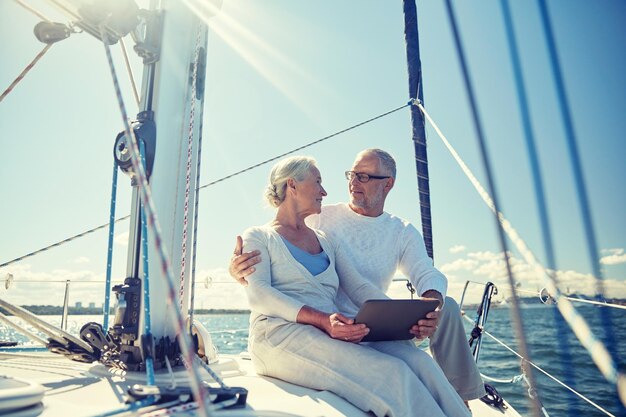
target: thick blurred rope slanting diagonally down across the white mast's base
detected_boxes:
[100,22,209,416]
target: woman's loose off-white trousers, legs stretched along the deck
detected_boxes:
[249,318,470,417]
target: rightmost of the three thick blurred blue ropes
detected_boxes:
[538,0,618,368]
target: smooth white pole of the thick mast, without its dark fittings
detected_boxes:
[135,1,207,341]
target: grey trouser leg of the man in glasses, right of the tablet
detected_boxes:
[430,297,486,400]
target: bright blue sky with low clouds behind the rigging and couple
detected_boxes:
[0,0,626,308]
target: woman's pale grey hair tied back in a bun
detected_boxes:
[265,156,317,207]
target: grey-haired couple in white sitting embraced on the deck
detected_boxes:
[230,149,484,417]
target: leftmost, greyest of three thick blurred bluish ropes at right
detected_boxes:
[438,0,539,416]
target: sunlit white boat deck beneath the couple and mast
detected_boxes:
[0,352,519,417]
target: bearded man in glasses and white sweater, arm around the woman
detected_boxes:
[230,149,485,403]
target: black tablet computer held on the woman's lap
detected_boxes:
[354,298,439,342]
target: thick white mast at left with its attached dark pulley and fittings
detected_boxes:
[110,0,207,370]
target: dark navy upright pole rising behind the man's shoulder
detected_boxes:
[403,0,433,258]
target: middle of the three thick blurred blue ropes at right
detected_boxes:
[500,0,576,414]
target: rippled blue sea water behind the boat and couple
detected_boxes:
[0,305,626,417]
